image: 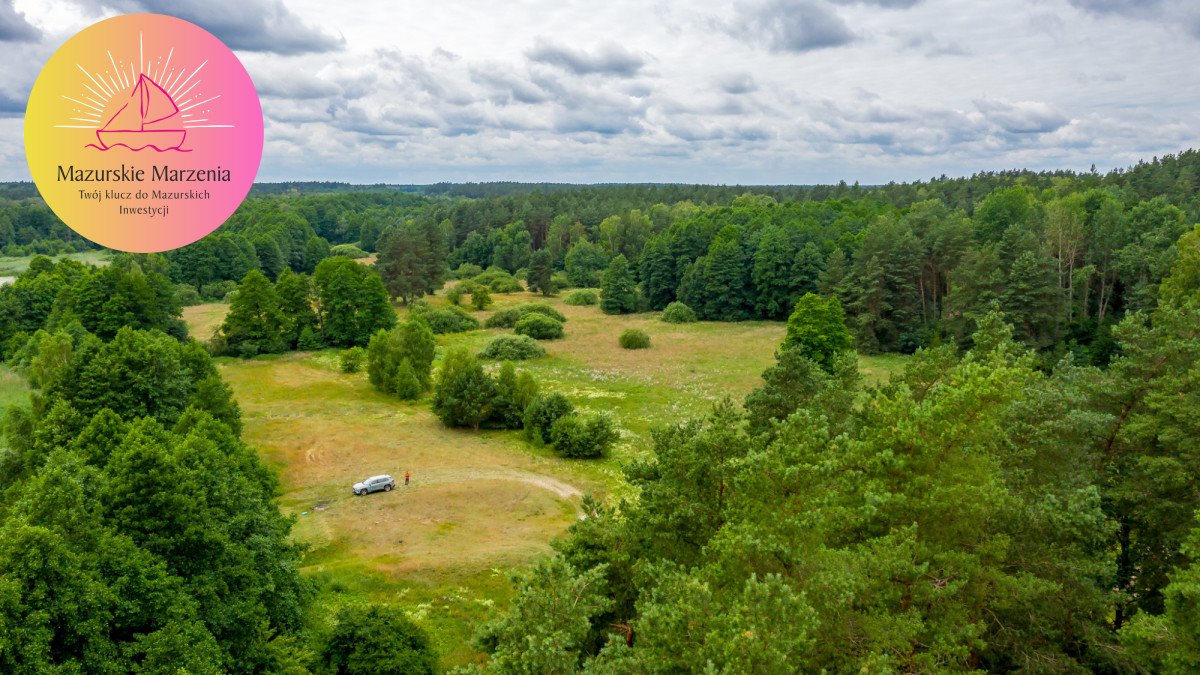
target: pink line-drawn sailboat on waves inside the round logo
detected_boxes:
[96,73,187,153]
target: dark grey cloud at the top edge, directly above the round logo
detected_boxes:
[73,0,346,55]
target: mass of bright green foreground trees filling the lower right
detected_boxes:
[465,227,1200,674]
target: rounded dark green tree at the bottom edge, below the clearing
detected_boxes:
[318,605,438,675]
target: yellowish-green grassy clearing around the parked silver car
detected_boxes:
[185,293,902,665]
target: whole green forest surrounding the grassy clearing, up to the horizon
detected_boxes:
[0,150,1200,674]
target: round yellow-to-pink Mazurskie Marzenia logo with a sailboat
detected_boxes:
[25,14,263,253]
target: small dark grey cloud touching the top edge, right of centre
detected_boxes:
[726,0,854,54]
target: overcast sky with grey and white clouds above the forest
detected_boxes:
[0,0,1200,184]
